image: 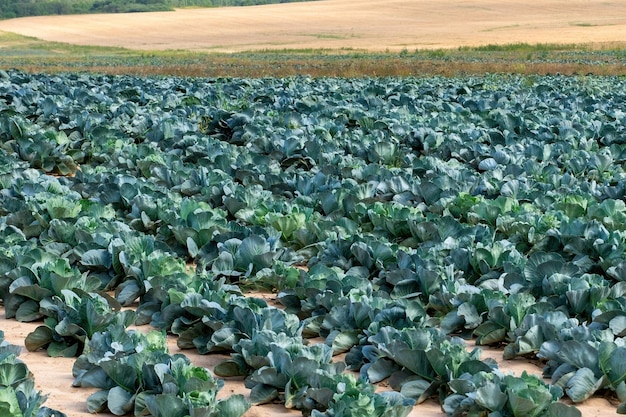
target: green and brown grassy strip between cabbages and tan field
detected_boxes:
[0,32,626,78]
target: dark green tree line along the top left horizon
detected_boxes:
[0,0,302,19]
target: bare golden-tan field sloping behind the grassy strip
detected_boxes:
[0,0,626,52]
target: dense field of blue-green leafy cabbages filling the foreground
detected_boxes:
[0,71,626,417]
